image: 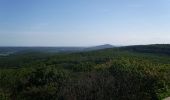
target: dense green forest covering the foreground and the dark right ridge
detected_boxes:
[0,44,170,100]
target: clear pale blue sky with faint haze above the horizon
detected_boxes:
[0,0,170,46]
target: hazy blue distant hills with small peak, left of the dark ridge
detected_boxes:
[0,44,114,56]
